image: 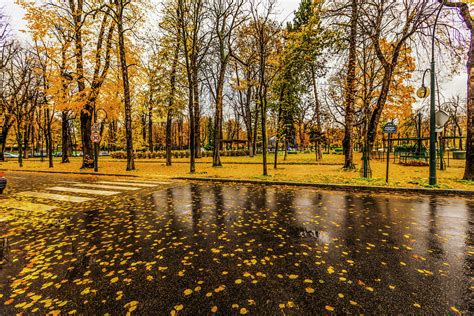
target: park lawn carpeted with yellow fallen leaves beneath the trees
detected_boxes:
[0,154,474,190]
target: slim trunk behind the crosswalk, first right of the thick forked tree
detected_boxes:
[117,1,135,171]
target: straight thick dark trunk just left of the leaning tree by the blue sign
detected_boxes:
[343,0,358,170]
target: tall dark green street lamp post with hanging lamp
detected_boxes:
[417,2,444,185]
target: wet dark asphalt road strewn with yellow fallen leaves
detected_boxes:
[0,173,474,315]
